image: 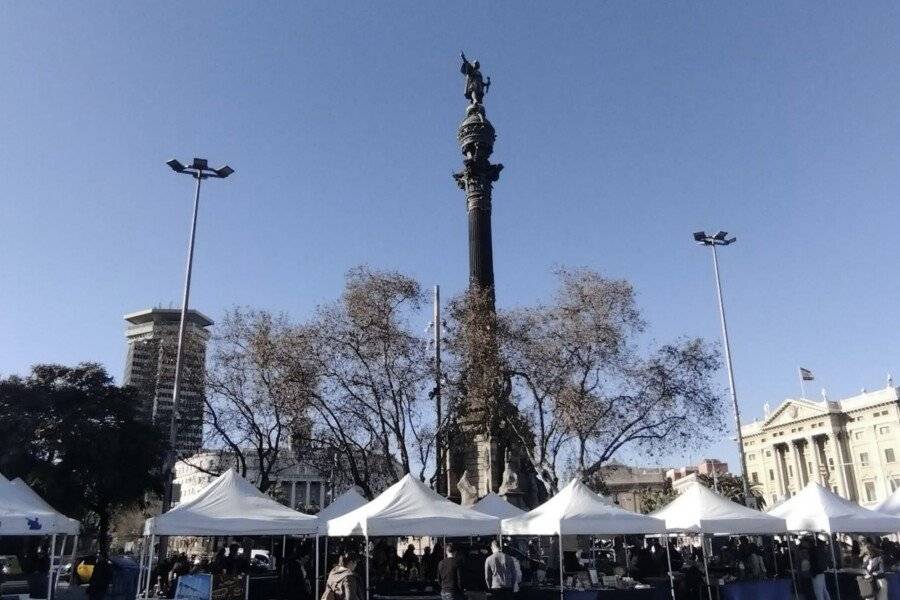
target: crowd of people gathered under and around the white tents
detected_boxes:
[135,535,900,600]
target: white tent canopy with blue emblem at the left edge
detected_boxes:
[0,476,79,536]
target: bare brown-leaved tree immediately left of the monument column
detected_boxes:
[290,267,433,497]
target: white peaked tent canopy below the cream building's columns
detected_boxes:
[769,482,900,533]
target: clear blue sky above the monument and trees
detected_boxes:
[0,1,900,462]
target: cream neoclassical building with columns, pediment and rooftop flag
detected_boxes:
[741,381,900,507]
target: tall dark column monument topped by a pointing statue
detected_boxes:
[447,53,535,507]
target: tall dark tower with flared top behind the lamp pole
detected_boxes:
[125,308,213,457]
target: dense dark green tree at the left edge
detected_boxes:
[0,363,165,551]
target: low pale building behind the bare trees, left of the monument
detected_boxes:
[173,450,332,514]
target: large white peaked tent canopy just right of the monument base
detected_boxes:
[500,478,666,535]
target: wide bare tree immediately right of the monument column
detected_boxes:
[504,270,722,493]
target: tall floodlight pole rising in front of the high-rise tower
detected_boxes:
[160,158,234,520]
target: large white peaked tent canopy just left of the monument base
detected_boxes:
[324,475,500,537]
